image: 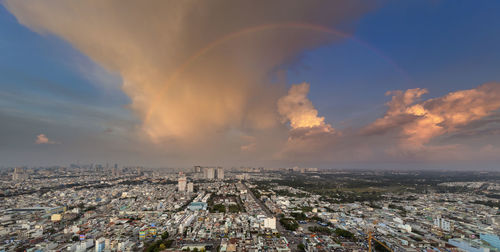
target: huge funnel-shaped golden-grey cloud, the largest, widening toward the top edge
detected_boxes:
[5,0,372,148]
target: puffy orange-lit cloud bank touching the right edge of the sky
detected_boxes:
[362,83,500,148]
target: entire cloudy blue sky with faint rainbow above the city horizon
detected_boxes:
[0,0,500,170]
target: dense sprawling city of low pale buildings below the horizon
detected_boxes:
[0,164,500,252]
